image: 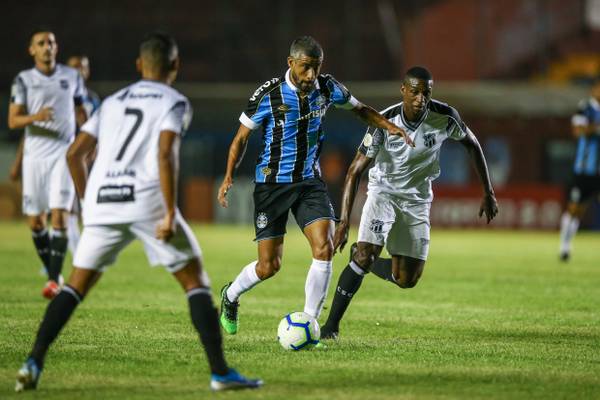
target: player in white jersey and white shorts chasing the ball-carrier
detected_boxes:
[321,67,498,339]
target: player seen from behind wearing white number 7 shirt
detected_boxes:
[15,33,262,391]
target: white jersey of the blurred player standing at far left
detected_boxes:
[10,64,86,160]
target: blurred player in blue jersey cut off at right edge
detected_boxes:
[560,78,600,261]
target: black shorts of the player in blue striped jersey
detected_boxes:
[254,178,335,241]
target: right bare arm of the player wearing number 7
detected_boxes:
[156,131,180,241]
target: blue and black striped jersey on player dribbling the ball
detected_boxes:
[240,70,358,183]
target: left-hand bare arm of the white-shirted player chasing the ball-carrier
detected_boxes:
[333,151,373,253]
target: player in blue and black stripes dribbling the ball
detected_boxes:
[218,36,411,334]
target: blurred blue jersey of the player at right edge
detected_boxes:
[572,97,600,176]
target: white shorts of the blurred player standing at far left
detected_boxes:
[23,155,75,215]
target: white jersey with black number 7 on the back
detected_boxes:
[81,80,192,225]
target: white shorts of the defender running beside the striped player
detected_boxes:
[358,193,431,260]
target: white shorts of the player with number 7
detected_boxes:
[73,213,208,276]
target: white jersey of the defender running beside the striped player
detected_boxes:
[359,100,468,203]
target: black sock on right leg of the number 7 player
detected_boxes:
[187,288,229,375]
